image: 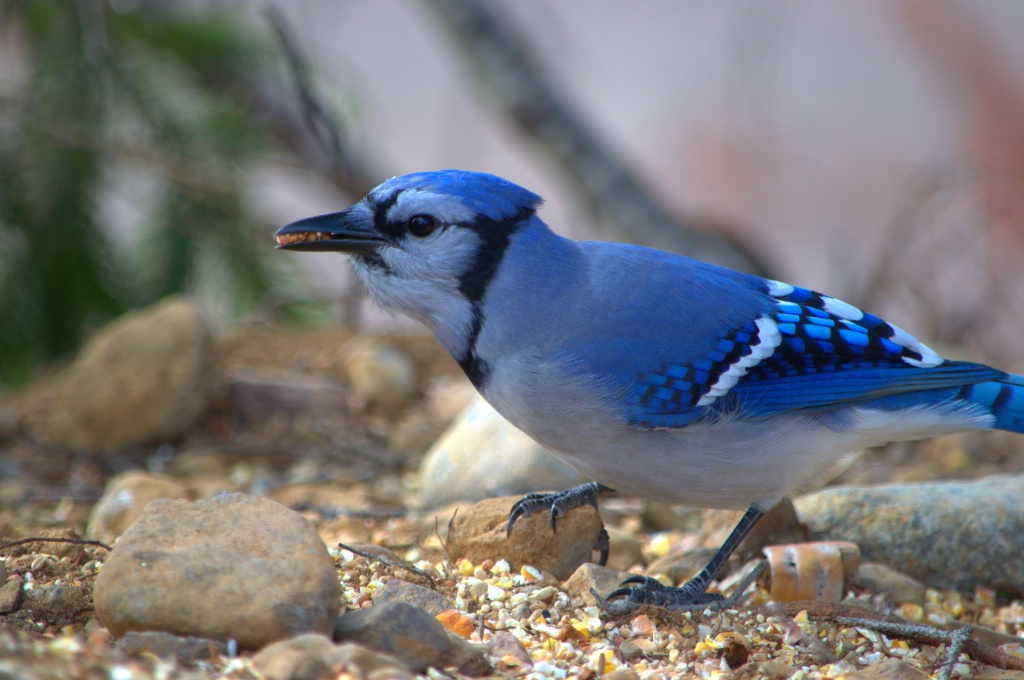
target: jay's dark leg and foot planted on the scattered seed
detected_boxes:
[608,506,765,609]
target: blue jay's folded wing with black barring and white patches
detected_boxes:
[627,282,1006,427]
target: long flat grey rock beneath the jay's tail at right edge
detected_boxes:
[797,475,1024,593]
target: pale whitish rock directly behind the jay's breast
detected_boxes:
[420,396,589,507]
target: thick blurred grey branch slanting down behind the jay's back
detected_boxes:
[419,0,766,273]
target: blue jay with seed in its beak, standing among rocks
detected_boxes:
[276,170,1024,607]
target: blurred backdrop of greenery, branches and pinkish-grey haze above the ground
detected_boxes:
[0,0,1024,390]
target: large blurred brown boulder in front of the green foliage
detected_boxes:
[45,297,219,453]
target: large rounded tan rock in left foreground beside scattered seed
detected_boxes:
[93,494,341,649]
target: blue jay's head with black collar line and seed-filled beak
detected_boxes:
[275,170,541,358]
